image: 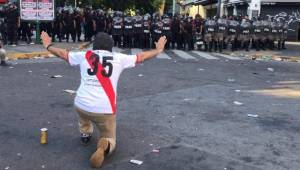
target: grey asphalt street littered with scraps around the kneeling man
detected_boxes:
[0,50,300,170]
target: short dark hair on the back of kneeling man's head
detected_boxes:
[93,32,114,52]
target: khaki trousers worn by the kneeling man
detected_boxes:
[75,107,116,154]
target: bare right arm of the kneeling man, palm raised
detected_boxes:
[137,36,167,63]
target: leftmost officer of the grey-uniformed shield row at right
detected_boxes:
[204,19,217,52]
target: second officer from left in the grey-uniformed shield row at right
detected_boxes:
[215,16,228,52]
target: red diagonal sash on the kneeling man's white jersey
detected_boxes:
[85,51,116,114]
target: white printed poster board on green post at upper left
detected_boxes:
[20,0,55,21]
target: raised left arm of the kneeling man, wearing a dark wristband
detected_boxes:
[41,31,69,61]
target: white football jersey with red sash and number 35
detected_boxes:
[69,50,137,114]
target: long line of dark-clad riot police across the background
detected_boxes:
[0,5,288,52]
